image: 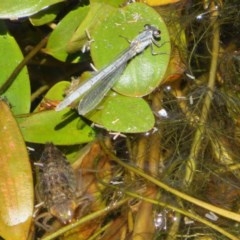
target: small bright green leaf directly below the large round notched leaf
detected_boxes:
[87,92,155,133]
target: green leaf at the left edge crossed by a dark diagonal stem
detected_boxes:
[0,21,31,114]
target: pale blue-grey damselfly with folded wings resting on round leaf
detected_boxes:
[55,24,161,115]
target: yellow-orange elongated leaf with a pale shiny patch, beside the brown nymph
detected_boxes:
[0,101,34,240]
